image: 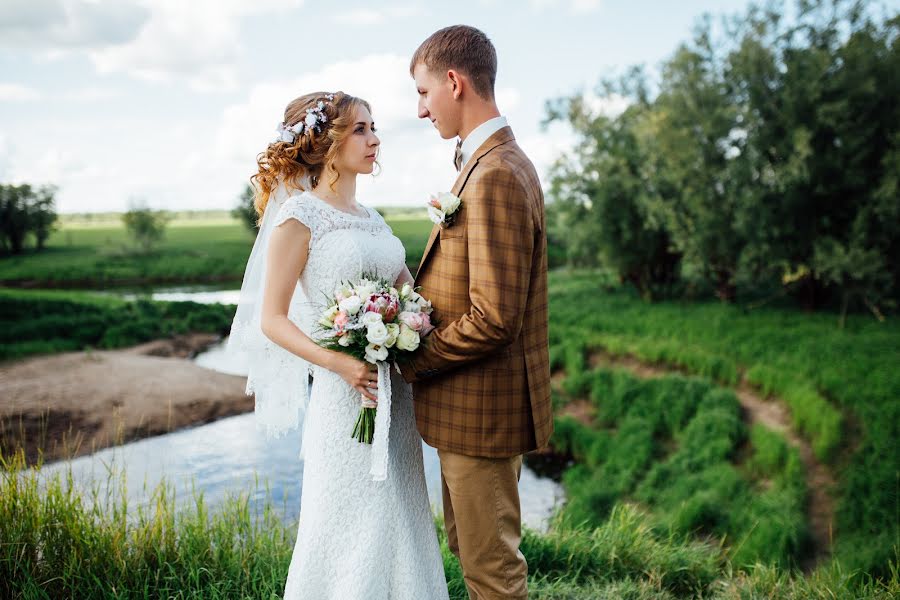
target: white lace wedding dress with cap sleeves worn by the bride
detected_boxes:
[274,192,448,600]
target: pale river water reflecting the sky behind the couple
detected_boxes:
[35,298,564,529]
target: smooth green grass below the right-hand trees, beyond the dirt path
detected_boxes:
[550,272,900,577]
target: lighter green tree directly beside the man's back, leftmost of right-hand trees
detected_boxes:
[547,70,680,299]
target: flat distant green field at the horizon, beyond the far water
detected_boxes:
[0,215,432,288]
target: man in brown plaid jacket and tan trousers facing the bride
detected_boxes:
[402,25,553,600]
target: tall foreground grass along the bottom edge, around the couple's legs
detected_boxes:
[0,454,900,600]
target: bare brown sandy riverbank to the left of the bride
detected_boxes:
[0,333,253,464]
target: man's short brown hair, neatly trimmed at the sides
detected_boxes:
[409,25,497,100]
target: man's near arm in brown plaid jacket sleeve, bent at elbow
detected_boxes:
[402,167,534,382]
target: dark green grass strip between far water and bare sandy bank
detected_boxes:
[0,288,235,360]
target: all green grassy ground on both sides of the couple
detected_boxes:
[0,217,900,599]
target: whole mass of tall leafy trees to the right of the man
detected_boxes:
[547,0,900,318]
